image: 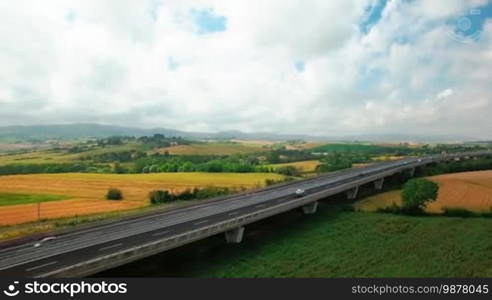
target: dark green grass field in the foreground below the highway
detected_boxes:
[191,210,492,277]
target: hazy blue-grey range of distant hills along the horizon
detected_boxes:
[0,124,473,143]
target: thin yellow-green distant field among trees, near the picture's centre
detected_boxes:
[158,143,268,155]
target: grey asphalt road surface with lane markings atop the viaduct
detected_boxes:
[0,152,484,277]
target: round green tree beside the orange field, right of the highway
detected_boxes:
[402,178,439,212]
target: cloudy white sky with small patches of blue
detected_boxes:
[0,0,492,139]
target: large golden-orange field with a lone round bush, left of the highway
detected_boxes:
[0,173,282,225]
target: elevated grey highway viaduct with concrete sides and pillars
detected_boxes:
[0,152,491,277]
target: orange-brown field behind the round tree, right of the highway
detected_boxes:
[355,171,492,213]
